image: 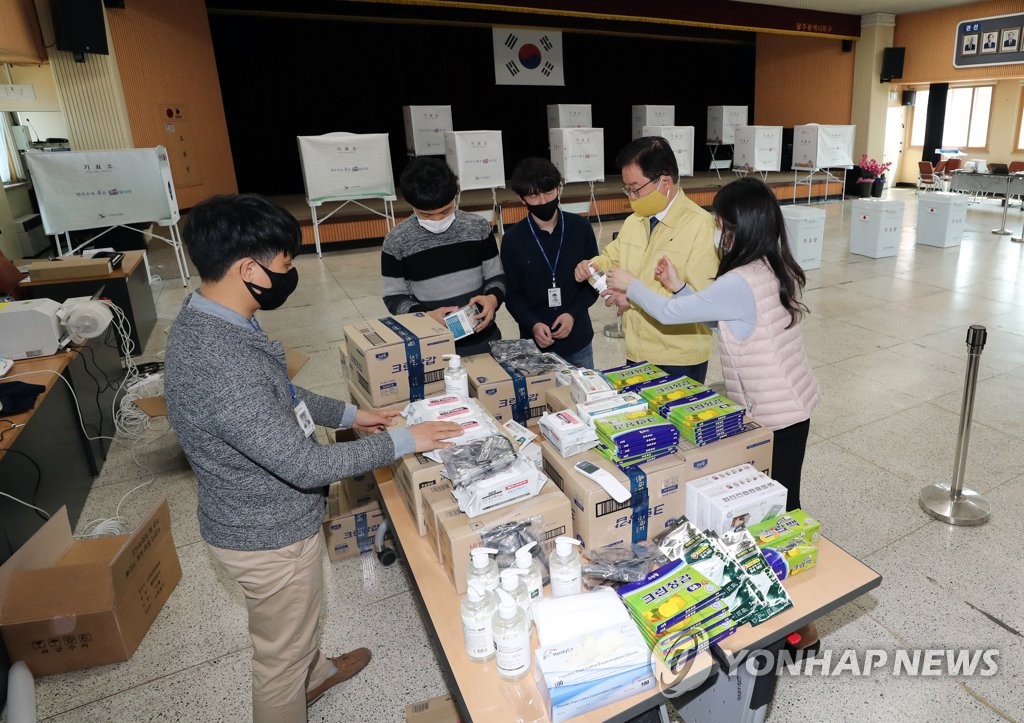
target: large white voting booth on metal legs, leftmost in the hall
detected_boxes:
[25,145,189,286]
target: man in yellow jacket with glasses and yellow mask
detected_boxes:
[575,136,719,382]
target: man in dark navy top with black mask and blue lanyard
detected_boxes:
[501,158,597,369]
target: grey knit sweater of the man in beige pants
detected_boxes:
[164,296,395,550]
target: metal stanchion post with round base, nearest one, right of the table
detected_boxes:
[919,325,992,524]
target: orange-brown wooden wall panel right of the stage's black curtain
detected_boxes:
[754,33,856,126]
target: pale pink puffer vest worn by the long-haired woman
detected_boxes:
[718,261,821,429]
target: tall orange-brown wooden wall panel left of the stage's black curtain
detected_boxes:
[106,0,238,208]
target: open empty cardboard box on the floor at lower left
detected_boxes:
[0,499,181,676]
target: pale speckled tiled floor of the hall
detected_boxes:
[12,190,1024,723]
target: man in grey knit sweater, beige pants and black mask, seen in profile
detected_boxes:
[164,196,462,723]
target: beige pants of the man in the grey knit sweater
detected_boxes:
[207,533,335,723]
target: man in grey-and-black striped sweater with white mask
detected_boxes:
[381,158,505,355]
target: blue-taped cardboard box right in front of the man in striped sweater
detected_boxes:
[345,312,455,408]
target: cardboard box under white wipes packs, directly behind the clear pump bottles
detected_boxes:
[437,483,572,595]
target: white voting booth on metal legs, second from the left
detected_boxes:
[297,131,396,256]
